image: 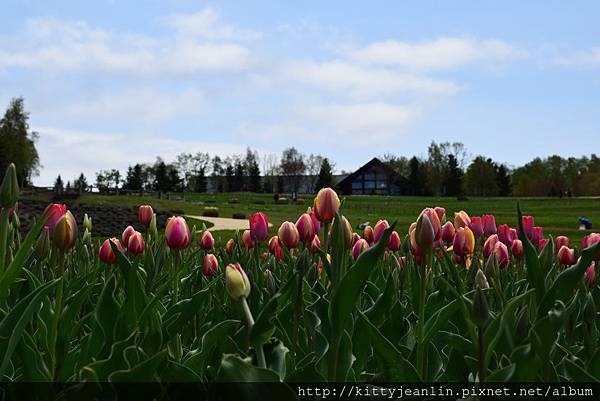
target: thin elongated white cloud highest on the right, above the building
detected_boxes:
[339,37,526,71]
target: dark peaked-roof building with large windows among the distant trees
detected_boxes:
[338,157,407,195]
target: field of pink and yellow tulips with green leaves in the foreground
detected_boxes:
[0,162,600,399]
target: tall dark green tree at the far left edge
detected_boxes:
[0,97,40,186]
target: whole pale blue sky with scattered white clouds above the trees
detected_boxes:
[0,0,600,185]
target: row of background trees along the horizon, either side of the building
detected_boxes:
[0,98,600,196]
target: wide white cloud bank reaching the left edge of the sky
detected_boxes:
[0,12,256,77]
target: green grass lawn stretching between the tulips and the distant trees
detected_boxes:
[22,193,600,242]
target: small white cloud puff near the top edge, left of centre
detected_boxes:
[162,8,262,41]
